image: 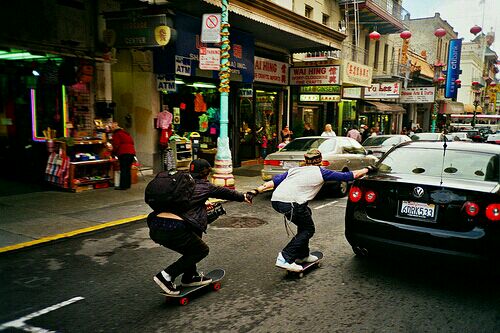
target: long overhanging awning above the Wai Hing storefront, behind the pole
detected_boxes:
[169,0,347,53]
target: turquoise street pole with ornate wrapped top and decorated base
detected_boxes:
[212,0,234,189]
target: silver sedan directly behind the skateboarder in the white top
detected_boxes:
[261,136,378,196]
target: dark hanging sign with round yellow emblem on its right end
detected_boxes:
[104,14,171,48]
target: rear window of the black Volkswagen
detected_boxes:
[379,147,500,182]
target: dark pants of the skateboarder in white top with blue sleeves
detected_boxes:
[272,201,316,263]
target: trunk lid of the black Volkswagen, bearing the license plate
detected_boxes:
[360,176,496,232]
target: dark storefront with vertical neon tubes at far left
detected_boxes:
[0,49,102,184]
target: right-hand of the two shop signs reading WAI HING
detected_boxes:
[290,66,340,86]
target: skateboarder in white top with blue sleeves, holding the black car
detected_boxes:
[247,149,375,272]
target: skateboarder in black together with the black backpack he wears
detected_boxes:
[145,159,251,295]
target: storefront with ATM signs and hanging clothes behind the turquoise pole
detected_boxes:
[154,12,255,169]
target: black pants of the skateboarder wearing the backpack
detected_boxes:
[149,226,209,281]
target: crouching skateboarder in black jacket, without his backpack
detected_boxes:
[147,159,251,295]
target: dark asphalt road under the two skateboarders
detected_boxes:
[0,194,500,332]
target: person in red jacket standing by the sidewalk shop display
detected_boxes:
[111,122,135,190]
